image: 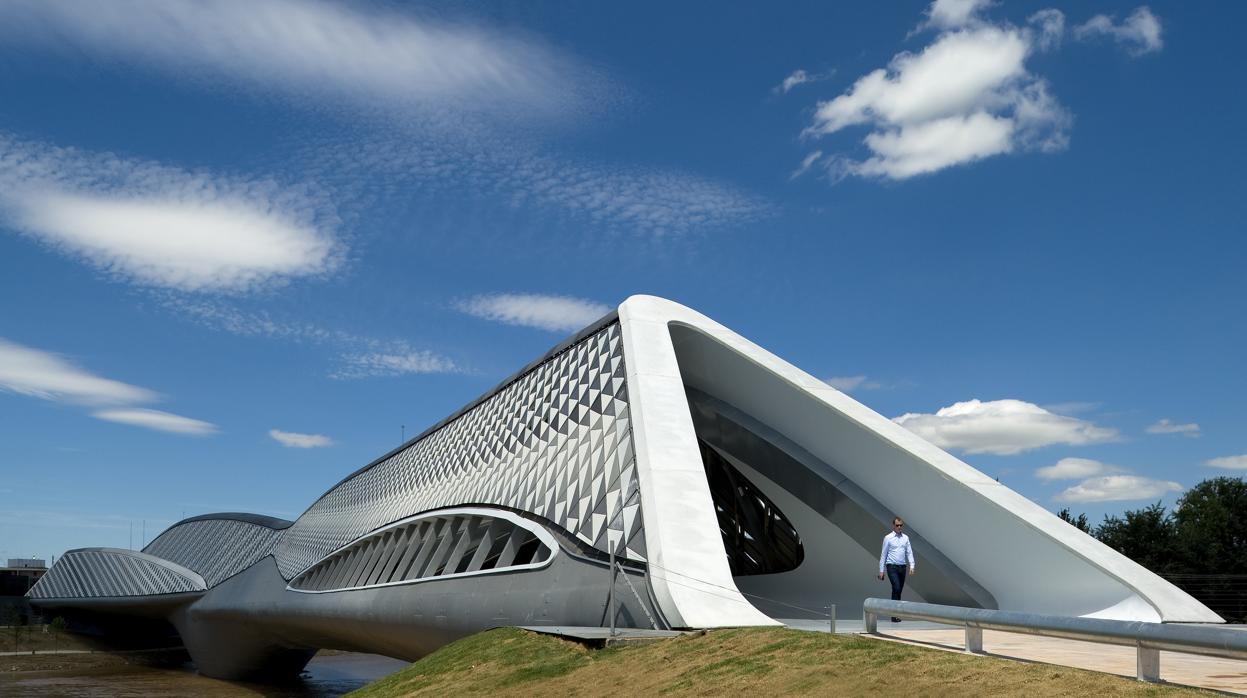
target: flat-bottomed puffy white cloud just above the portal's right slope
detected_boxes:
[893,400,1119,455]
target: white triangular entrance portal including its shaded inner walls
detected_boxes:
[620,297,1221,626]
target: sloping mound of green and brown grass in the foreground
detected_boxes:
[350,628,1210,698]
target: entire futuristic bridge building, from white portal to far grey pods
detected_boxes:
[29,295,1221,678]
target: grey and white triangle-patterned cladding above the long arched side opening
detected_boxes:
[276,322,646,578]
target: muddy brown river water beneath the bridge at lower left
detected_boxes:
[0,653,407,698]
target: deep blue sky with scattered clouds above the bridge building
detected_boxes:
[0,0,1247,557]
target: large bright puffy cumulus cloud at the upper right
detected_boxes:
[803,0,1070,179]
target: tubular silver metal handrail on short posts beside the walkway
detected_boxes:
[862,598,1247,682]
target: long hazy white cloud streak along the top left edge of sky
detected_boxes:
[0,0,592,115]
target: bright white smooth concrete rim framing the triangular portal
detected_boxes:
[619,295,1223,627]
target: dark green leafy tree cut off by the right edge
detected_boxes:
[1173,477,1247,575]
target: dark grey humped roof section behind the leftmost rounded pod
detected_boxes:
[143,520,282,587]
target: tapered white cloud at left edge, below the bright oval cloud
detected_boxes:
[0,338,157,405]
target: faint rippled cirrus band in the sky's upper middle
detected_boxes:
[298,131,778,236]
